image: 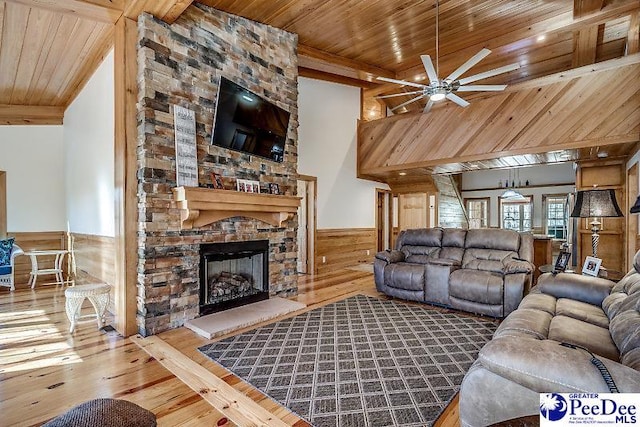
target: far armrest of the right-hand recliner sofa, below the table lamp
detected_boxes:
[537,273,615,307]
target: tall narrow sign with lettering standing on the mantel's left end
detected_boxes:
[173,105,198,187]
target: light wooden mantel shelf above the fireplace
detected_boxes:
[173,187,300,230]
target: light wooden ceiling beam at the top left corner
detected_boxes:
[6,0,124,24]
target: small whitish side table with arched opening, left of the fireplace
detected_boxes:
[64,283,111,333]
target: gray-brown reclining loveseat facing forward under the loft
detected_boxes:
[373,228,534,317]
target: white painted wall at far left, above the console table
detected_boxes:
[0,126,66,232]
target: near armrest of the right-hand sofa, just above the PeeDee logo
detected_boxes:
[478,337,640,393]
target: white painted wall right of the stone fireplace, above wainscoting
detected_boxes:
[298,77,388,229]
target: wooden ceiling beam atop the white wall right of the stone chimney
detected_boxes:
[298,44,395,87]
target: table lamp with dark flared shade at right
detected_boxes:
[570,189,623,258]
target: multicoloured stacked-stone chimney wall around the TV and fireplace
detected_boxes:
[137,3,298,336]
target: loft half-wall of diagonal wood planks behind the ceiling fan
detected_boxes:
[358,54,640,176]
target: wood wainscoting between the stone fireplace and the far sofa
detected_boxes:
[316,228,376,274]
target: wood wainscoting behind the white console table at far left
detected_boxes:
[8,231,67,289]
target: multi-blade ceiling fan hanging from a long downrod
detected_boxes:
[377,1,520,113]
